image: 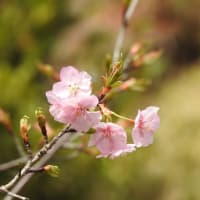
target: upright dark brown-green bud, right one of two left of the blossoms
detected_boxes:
[35,108,48,144]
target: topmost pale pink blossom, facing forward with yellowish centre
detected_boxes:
[47,66,91,98]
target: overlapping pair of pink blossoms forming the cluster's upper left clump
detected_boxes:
[46,66,101,132]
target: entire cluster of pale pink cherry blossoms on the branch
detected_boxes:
[46,66,160,158]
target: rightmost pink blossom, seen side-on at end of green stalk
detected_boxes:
[132,106,160,147]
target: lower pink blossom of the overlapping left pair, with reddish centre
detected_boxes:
[47,93,101,132]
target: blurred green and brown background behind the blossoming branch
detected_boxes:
[0,0,200,200]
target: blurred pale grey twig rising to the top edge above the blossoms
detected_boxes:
[112,0,138,63]
